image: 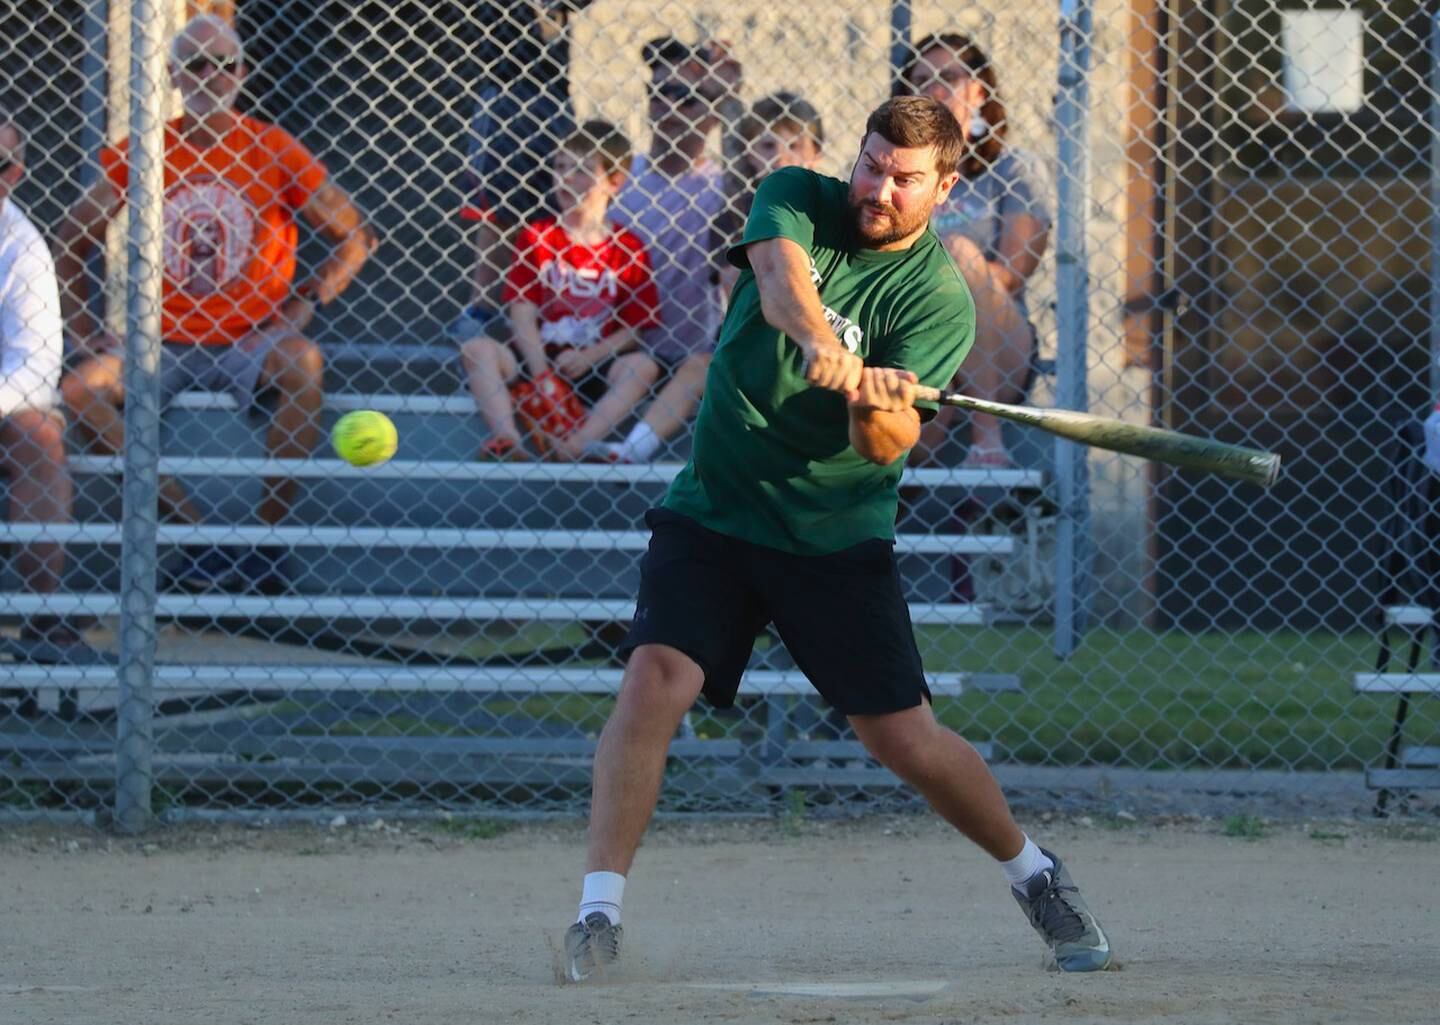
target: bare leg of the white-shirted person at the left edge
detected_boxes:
[0,409,72,595]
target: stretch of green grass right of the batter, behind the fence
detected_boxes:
[917,628,1411,770]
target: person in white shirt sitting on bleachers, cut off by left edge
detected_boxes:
[0,111,94,662]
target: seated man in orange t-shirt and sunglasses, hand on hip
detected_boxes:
[56,14,374,593]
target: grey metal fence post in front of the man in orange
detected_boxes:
[115,0,168,834]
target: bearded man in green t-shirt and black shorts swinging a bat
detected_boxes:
[564,96,1110,982]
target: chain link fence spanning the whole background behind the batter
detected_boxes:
[0,0,1440,828]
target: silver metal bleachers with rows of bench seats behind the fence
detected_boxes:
[0,347,1043,782]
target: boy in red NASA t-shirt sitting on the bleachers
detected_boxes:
[461,121,660,461]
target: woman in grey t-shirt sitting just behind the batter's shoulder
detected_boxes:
[903,32,1050,468]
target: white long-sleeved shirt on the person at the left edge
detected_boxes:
[0,199,65,416]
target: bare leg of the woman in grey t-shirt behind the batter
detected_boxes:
[950,239,1031,453]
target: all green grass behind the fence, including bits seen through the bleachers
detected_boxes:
[270,625,1440,772]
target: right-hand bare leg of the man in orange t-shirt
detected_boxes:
[258,334,325,524]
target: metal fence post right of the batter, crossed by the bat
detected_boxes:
[1054,0,1092,658]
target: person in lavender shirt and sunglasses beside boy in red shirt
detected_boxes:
[586,36,740,462]
